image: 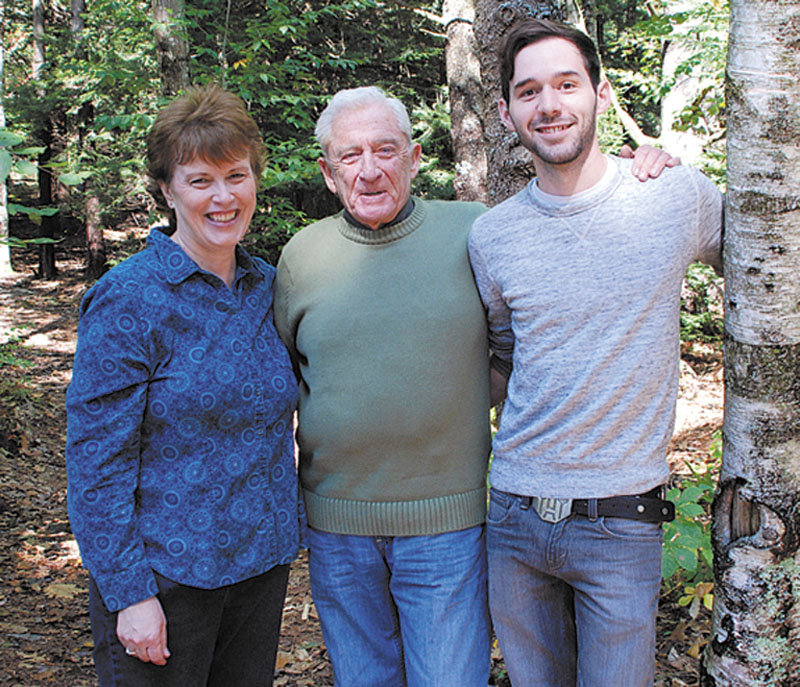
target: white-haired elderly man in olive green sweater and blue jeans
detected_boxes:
[275,87,666,687]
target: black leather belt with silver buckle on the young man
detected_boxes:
[520,487,675,523]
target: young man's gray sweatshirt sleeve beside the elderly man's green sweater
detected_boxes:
[469,220,514,378]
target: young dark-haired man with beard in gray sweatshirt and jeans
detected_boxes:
[469,20,722,687]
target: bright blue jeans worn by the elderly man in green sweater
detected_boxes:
[309,526,490,687]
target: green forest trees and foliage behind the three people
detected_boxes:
[0,0,728,276]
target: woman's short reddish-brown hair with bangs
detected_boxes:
[147,84,265,218]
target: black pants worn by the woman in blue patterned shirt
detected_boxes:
[89,565,289,687]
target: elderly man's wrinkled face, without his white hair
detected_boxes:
[319,103,420,229]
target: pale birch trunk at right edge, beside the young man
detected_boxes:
[702,0,800,687]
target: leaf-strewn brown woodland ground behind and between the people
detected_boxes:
[0,235,722,687]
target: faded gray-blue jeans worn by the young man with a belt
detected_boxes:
[487,489,662,687]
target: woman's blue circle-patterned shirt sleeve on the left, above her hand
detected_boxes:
[66,280,157,612]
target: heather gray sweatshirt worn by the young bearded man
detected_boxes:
[469,157,722,498]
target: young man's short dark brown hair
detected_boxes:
[500,19,600,102]
